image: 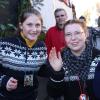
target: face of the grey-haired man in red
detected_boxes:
[55,10,67,29]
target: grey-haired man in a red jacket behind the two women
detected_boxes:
[45,8,67,55]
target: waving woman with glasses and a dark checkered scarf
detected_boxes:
[48,20,100,100]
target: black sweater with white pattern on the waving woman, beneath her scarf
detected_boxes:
[48,48,100,100]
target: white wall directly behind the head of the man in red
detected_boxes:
[33,0,72,29]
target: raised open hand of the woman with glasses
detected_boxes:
[49,47,62,71]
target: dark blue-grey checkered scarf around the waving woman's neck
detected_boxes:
[62,44,92,80]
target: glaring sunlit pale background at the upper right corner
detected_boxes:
[72,0,100,26]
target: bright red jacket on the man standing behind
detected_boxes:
[45,26,65,54]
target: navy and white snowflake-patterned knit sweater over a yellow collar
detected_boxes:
[0,36,47,100]
